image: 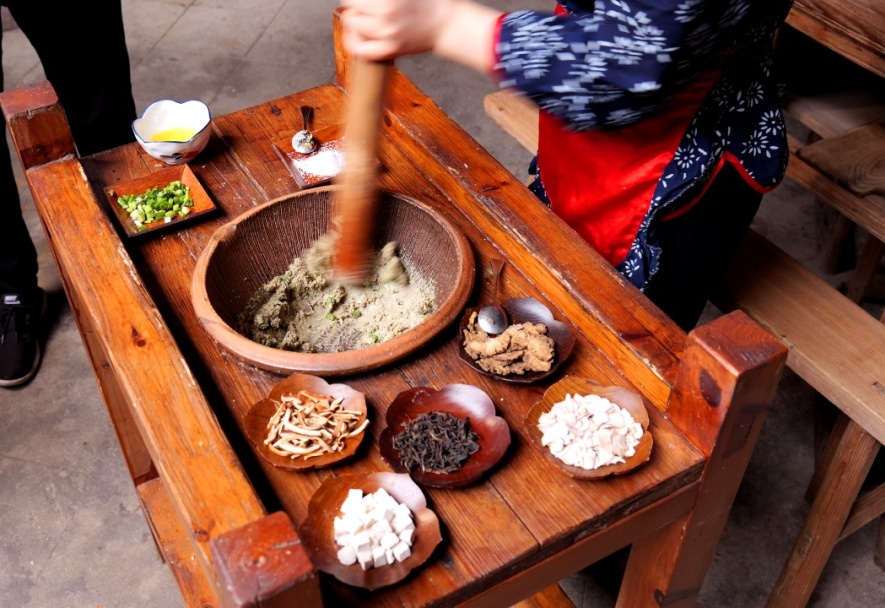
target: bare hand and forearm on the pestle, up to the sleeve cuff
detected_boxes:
[341,0,502,73]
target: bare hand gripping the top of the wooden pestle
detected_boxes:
[341,0,459,61]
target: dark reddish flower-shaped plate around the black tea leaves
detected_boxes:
[378,384,510,488]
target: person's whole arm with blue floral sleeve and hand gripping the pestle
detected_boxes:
[342,0,790,130]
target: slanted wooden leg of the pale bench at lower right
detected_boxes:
[767,421,879,608]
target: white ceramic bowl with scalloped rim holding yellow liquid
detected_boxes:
[132,99,212,165]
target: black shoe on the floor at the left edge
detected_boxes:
[0,287,46,387]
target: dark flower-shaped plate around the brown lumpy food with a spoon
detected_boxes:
[458,298,575,384]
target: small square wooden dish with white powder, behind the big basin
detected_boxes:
[274,125,344,190]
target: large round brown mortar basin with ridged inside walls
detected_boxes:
[192,186,475,376]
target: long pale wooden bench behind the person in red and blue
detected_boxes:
[484,85,885,606]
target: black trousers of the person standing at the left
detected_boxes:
[0,0,136,292]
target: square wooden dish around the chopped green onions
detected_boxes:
[104,165,216,238]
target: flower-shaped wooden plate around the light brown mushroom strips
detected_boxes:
[243,373,367,470]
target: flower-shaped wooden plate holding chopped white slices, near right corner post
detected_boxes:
[525,376,653,479]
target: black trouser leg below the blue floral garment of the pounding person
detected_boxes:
[645,164,762,331]
